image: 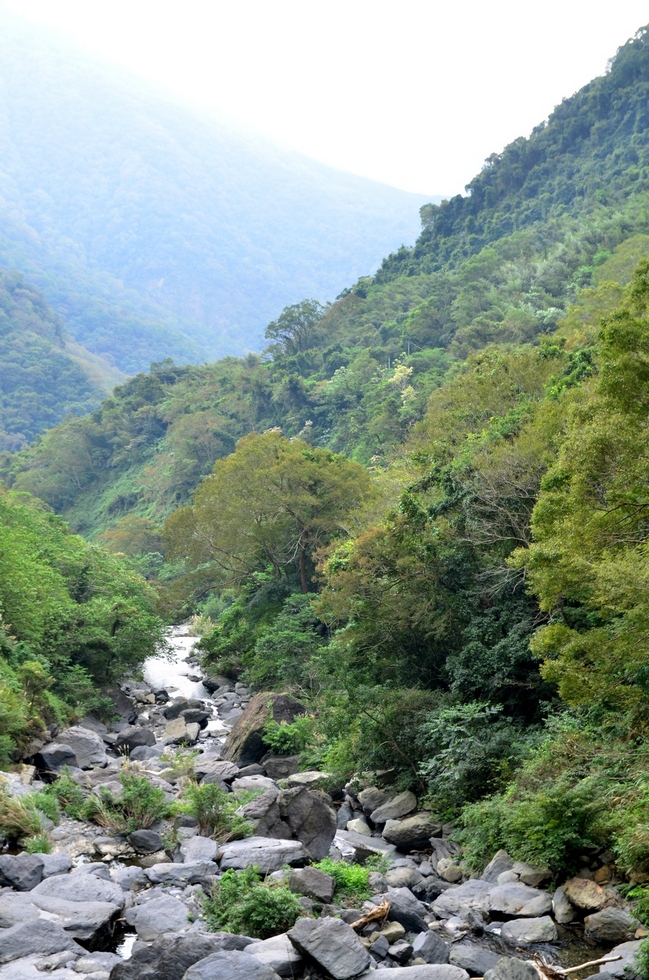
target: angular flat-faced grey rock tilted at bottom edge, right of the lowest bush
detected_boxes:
[288,918,370,980]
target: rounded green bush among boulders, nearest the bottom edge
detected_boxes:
[203,865,302,939]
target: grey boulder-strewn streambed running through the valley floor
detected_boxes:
[0,629,640,980]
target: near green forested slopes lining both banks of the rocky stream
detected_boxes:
[6,21,649,915]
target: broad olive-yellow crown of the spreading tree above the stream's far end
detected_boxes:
[165,430,370,592]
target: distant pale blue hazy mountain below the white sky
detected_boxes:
[0,14,425,373]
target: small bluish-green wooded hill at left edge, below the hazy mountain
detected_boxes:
[0,269,120,450]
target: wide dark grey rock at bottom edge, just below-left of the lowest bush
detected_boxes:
[110,932,254,980]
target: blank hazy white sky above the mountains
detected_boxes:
[0,0,649,194]
